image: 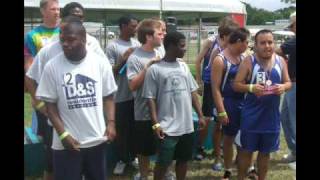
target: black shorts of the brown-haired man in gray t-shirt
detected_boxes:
[134,120,156,156]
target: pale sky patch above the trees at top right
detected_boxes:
[240,0,291,11]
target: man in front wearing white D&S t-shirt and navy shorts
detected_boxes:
[36,17,117,180]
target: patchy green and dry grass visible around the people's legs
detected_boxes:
[24,64,295,180]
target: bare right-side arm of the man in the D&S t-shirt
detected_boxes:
[103,94,116,141]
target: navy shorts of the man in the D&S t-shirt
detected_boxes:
[53,143,107,180]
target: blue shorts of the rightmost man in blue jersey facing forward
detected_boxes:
[240,131,280,154]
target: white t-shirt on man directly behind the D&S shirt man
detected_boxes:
[26,34,109,84]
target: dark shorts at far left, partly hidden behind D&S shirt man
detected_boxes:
[36,111,53,172]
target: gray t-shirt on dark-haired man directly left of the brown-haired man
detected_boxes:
[106,38,140,102]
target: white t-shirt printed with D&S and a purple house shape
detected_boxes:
[36,49,117,150]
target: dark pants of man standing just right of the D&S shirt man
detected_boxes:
[115,100,135,163]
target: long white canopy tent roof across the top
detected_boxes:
[24,0,246,14]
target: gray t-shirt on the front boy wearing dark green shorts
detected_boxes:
[142,60,198,136]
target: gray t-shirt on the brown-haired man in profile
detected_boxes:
[127,48,158,121]
